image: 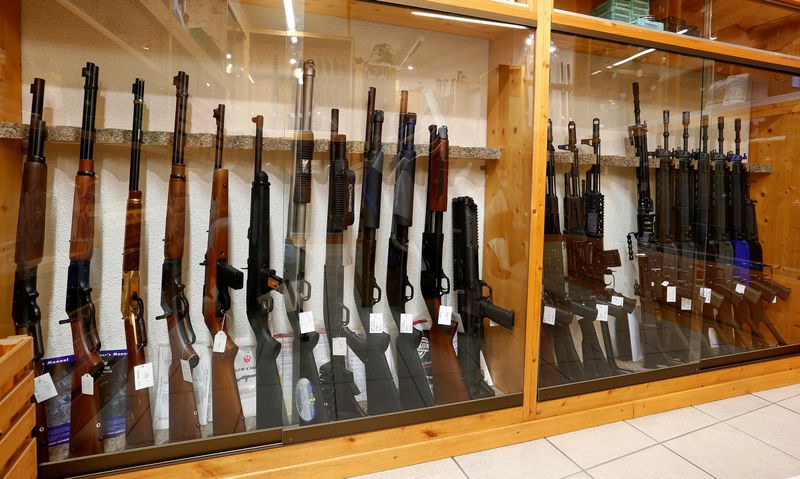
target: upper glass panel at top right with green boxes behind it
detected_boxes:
[554,0,800,55]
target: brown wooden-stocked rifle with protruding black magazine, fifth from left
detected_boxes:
[200,104,247,436]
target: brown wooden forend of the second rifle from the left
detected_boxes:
[69,159,95,261]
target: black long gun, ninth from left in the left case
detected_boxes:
[342,88,400,415]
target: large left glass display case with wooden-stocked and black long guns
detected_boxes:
[0,0,534,476]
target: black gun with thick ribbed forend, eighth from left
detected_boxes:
[319,108,365,419]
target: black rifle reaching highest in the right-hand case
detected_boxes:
[628,82,675,368]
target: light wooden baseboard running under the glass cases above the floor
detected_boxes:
[109,357,800,479]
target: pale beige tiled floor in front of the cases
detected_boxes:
[358,384,800,479]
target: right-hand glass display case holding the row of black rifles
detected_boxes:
[539,30,800,399]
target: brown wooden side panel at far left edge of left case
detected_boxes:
[0,0,22,337]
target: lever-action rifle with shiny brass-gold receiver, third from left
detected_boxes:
[122,78,154,449]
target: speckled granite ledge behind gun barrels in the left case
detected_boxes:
[0,122,500,160]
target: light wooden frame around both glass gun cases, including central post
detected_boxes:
[0,0,800,479]
